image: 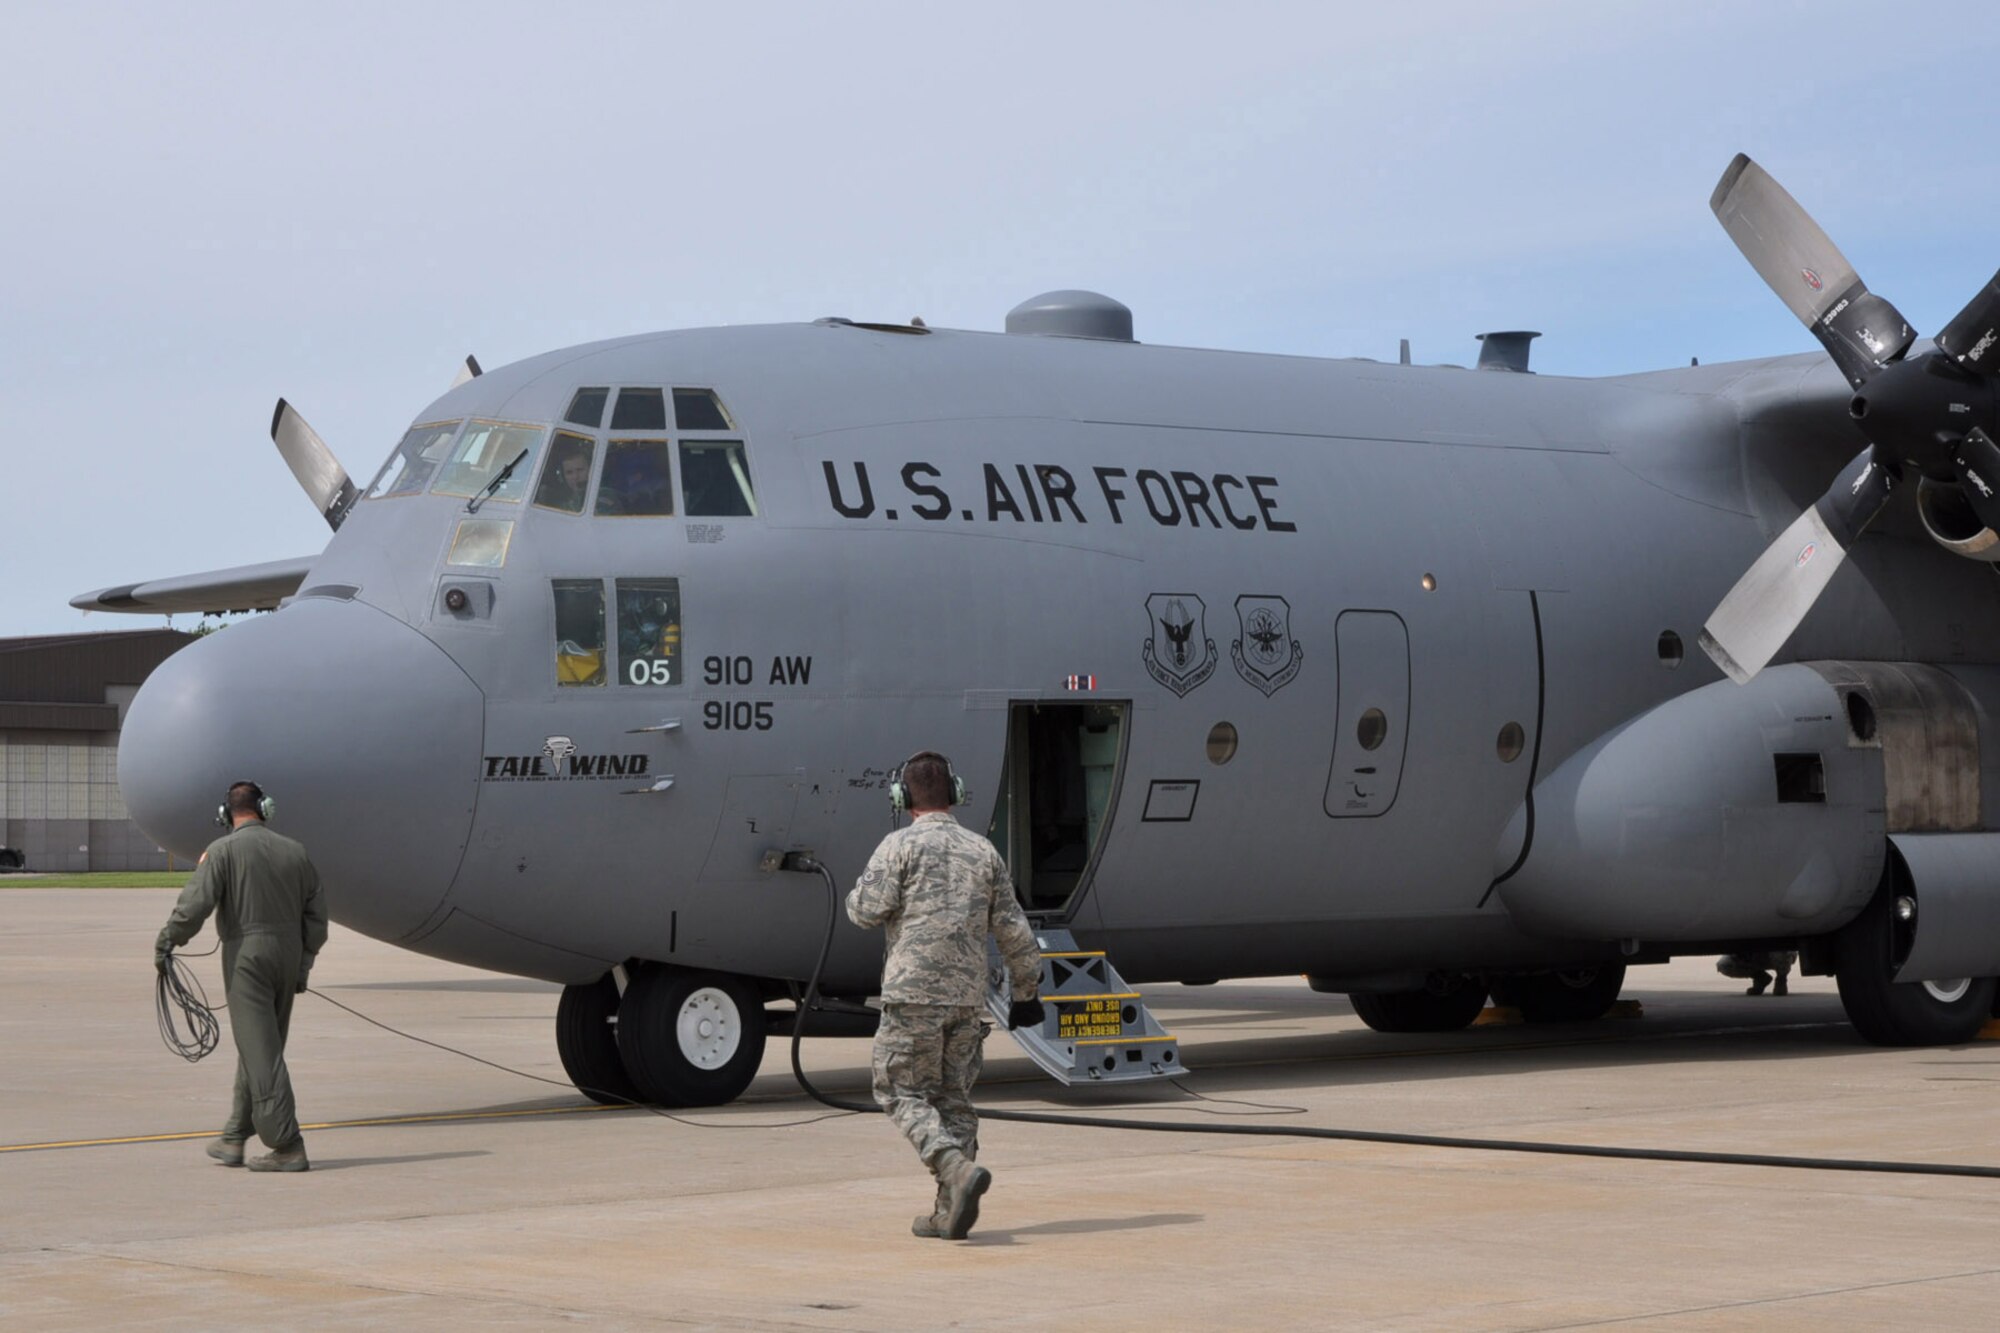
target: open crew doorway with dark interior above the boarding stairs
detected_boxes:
[986,701,1130,908]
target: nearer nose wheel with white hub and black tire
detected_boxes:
[618,963,766,1107]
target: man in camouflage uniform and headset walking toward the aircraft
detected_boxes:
[848,751,1042,1241]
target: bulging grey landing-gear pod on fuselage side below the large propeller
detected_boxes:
[1500,662,1994,943]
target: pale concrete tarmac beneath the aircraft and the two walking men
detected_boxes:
[11,881,2000,1331]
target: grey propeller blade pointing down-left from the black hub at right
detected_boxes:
[1700,444,1896,685]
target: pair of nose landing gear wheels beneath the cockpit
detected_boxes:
[556,963,764,1107]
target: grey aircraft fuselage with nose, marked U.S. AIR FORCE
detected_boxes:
[113,324,2000,993]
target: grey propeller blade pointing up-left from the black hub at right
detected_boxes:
[1708,152,1916,388]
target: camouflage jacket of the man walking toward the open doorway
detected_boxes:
[848,811,1042,1007]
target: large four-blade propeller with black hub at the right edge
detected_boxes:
[1702,154,2000,683]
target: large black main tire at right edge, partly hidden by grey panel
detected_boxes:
[1834,875,1994,1047]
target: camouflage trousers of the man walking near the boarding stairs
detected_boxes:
[874,1003,988,1171]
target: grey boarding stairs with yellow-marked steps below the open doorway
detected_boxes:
[986,929,1180,1087]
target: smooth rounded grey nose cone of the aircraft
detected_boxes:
[118,598,484,939]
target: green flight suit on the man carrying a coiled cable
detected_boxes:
[158,823,326,1149]
